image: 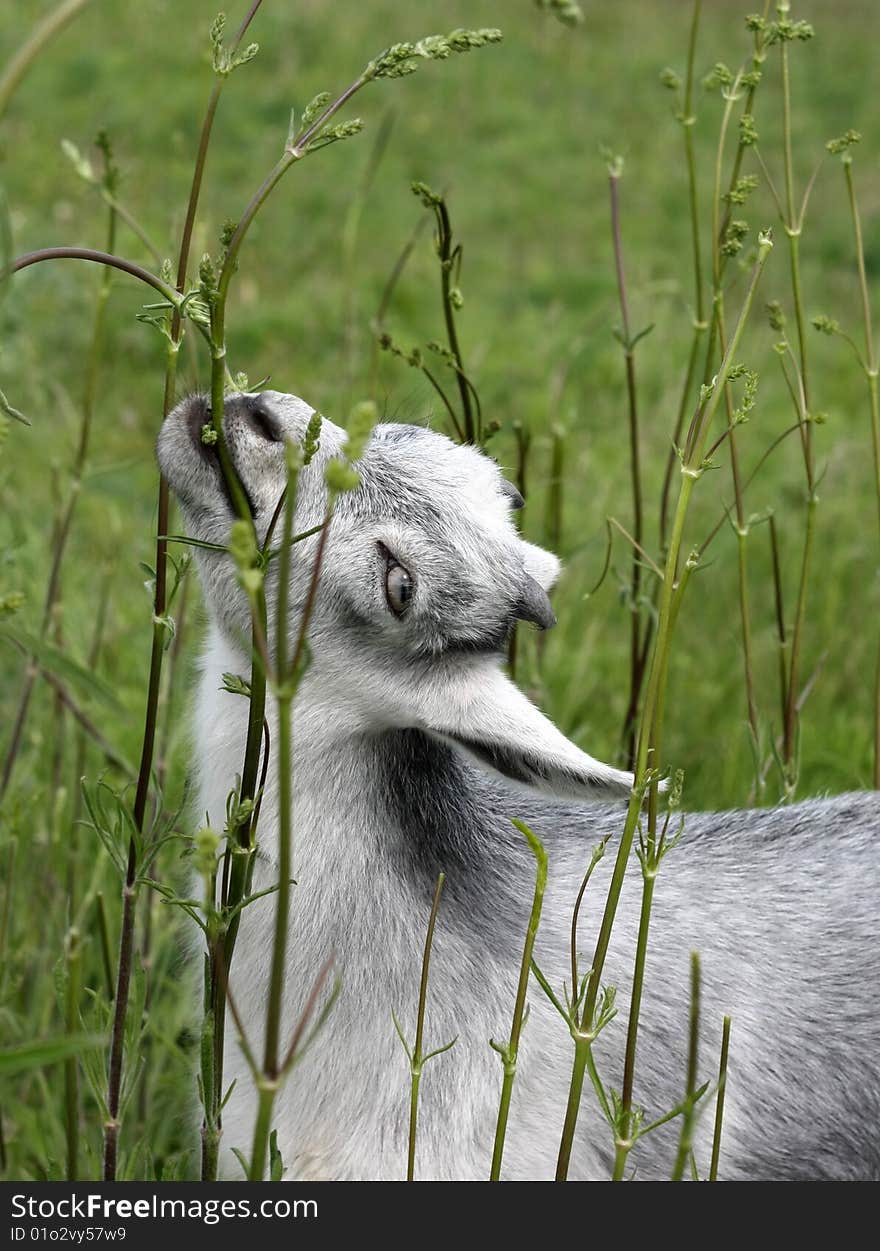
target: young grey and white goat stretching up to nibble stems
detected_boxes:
[159,392,880,1178]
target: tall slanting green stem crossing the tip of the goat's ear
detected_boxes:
[556,236,771,1181]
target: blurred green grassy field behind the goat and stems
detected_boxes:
[0,0,880,1177]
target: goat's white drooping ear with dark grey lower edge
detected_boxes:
[419,662,632,799]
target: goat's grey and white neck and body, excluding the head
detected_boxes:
[197,629,880,1180]
